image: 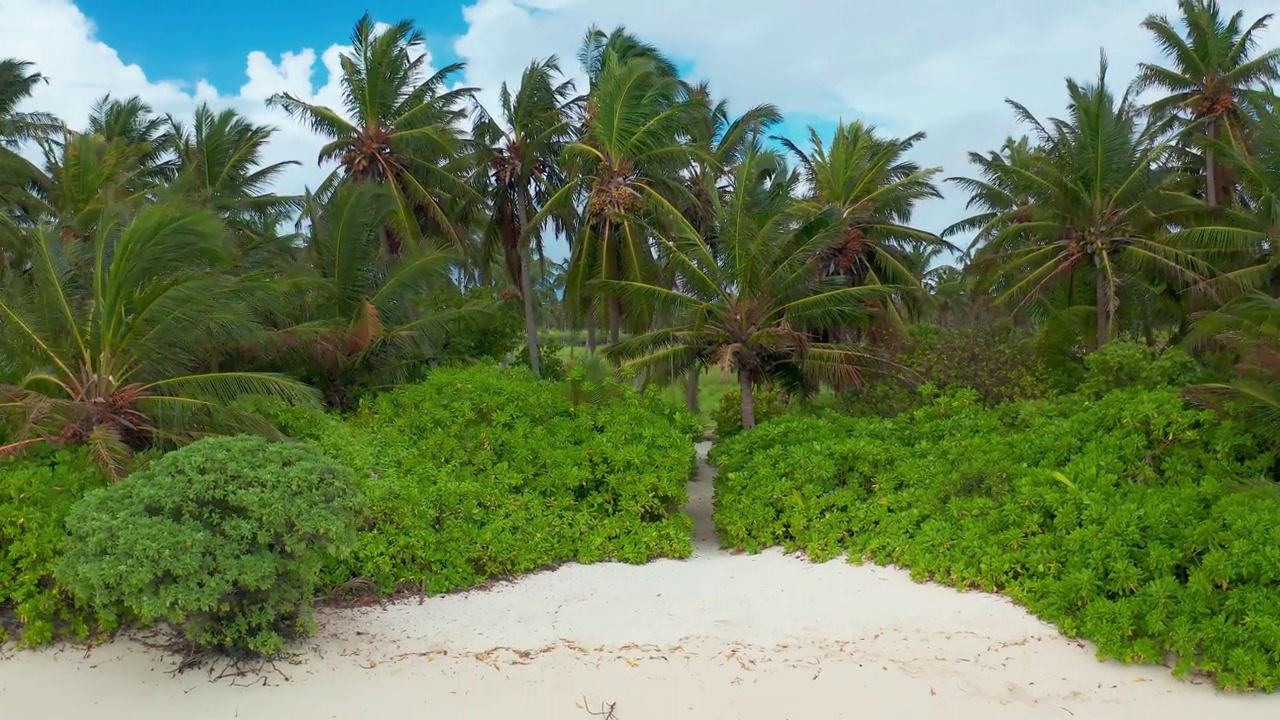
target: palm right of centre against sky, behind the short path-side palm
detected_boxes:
[777,122,955,333]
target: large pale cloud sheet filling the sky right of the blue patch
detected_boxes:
[456,0,1280,240]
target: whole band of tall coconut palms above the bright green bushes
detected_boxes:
[0,0,1280,466]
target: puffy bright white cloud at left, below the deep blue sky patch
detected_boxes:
[0,0,371,192]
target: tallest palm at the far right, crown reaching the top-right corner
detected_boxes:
[1134,0,1280,206]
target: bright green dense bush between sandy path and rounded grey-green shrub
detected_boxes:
[276,366,699,593]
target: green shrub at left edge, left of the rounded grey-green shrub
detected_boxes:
[0,448,108,646]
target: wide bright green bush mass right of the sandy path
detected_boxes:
[713,386,1280,689]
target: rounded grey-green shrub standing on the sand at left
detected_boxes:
[58,437,361,655]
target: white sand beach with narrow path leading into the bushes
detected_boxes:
[0,440,1280,720]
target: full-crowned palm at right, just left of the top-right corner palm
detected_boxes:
[961,55,1211,346]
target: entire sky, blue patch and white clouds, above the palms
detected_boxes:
[0,0,1280,260]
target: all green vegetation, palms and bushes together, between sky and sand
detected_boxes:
[0,0,1280,688]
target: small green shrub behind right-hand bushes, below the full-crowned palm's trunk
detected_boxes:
[1080,340,1203,397]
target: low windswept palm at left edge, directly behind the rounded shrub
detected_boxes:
[0,204,315,477]
